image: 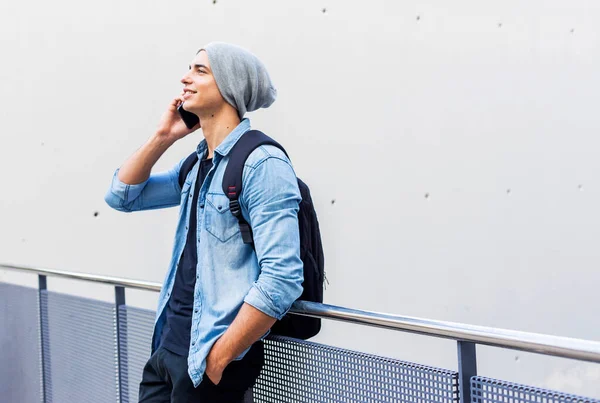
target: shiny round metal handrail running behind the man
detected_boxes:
[0,264,600,363]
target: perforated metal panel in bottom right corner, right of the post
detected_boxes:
[471,376,600,403]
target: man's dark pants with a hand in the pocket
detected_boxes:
[139,341,264,403]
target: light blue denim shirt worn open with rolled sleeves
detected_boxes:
[105,119,304,386]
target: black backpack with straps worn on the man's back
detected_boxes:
[179,130,325,340]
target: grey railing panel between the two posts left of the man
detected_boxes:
[42,291,117,403]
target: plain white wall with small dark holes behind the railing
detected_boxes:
[0,0,600,397]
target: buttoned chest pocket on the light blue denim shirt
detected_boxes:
[204,193,240,242]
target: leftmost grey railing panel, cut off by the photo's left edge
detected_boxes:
[0,283,42,403]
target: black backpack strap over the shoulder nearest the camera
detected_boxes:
[223,130,287,244]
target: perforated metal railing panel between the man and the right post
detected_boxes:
[253,336,458,403]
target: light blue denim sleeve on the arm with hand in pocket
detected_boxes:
[240,157,304,319]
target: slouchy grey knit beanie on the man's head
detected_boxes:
[199,42,277,119]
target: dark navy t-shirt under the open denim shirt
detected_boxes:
[161,159,212,357]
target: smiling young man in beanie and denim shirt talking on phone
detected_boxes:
[105,43,303,403]
